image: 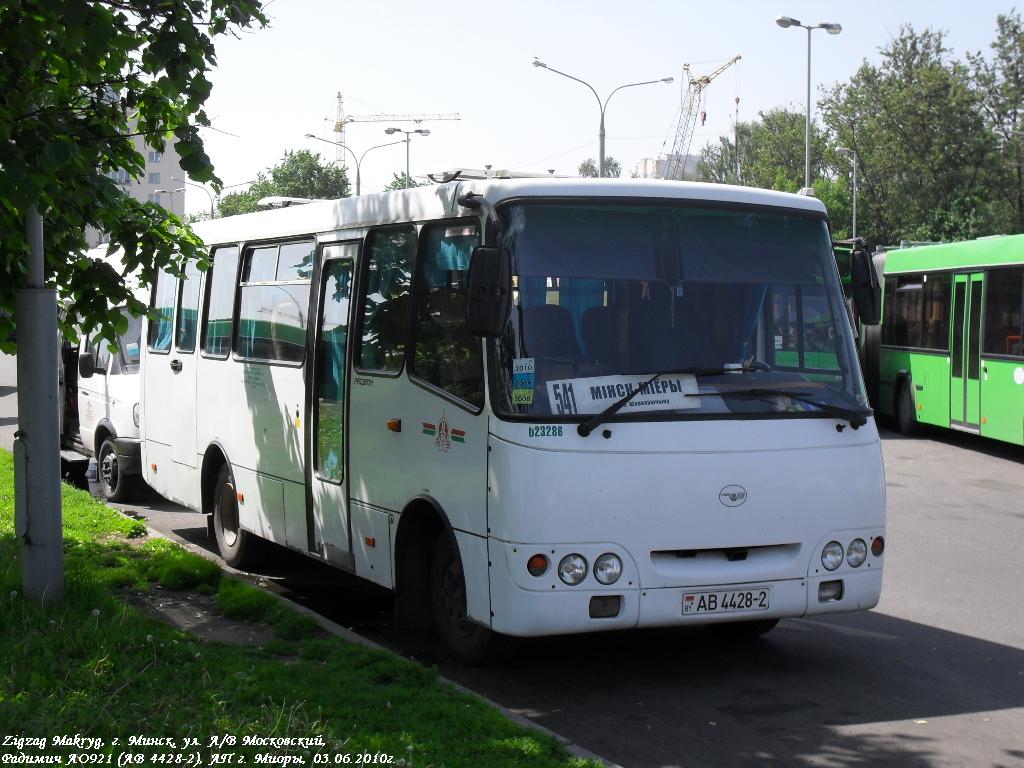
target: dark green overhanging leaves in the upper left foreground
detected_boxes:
[0,0,266,351]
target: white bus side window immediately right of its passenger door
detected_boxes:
[356,226,416,373]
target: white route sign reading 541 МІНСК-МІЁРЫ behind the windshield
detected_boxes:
[548,374,700,415]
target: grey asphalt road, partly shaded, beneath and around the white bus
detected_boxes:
[0,355,1024,768]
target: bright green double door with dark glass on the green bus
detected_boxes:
[949,272,984,430]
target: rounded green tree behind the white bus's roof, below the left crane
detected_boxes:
[217,150,349,216]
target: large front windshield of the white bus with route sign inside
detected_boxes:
[492,201,867,419]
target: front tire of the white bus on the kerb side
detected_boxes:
[430,531,511,666]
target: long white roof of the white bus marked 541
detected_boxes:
[193,178,825,245]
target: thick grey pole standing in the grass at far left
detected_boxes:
[14,206,63,601]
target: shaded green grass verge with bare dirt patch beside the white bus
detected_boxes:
[0,451,589,768]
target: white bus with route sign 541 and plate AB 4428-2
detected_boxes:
[142,179,885,663]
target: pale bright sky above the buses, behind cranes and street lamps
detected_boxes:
[185,0,1014,217]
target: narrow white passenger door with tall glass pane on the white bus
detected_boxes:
[306,252,357,569]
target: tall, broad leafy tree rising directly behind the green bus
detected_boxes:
[820,27,998,243]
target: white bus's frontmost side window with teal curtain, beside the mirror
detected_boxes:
[411,223,483,408]
